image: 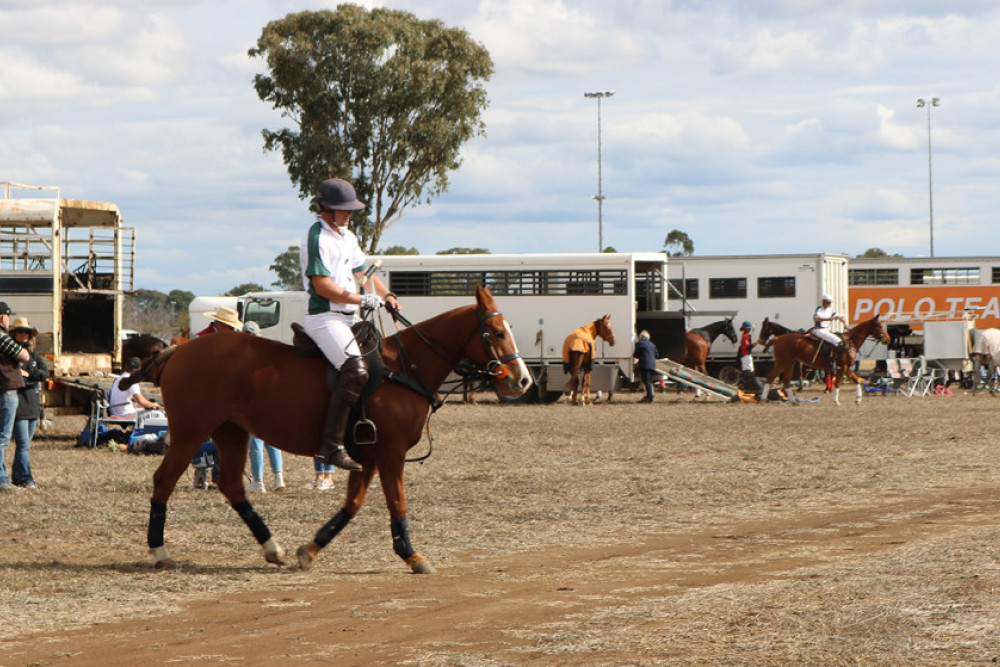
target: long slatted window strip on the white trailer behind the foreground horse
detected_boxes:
[389,270,628,296]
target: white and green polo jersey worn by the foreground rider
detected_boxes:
[299,218,368,315]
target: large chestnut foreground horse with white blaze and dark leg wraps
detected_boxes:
[129,287,532,573]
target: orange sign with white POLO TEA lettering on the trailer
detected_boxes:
[848,285,1000,329]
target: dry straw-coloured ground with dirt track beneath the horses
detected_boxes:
[0,391,1000,667]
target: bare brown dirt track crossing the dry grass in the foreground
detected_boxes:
[13,487,1000,665]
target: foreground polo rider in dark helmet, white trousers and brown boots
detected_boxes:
[299,178,399,470]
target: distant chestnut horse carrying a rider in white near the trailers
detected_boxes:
[762,315,889,405]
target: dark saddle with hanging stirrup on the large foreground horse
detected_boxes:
[292,320,386,461]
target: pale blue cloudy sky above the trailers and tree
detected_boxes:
[0,0,1000,295]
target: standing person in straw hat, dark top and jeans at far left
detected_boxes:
[10,317,49,489]
